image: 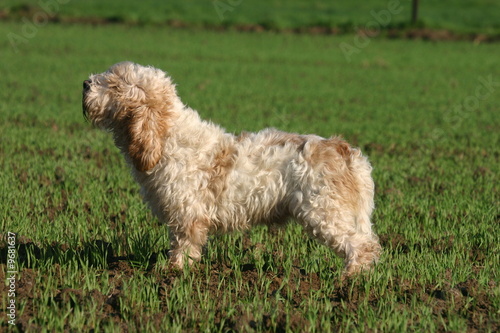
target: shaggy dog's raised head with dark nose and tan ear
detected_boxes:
[82,62,178,171]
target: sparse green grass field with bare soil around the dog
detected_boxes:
[0,10,500,332]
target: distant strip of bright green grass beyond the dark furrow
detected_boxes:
[2,0,500,33]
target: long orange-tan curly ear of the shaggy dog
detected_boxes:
[126,96,172,171]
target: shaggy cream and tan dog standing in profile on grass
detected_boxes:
[83,62,380,275]
